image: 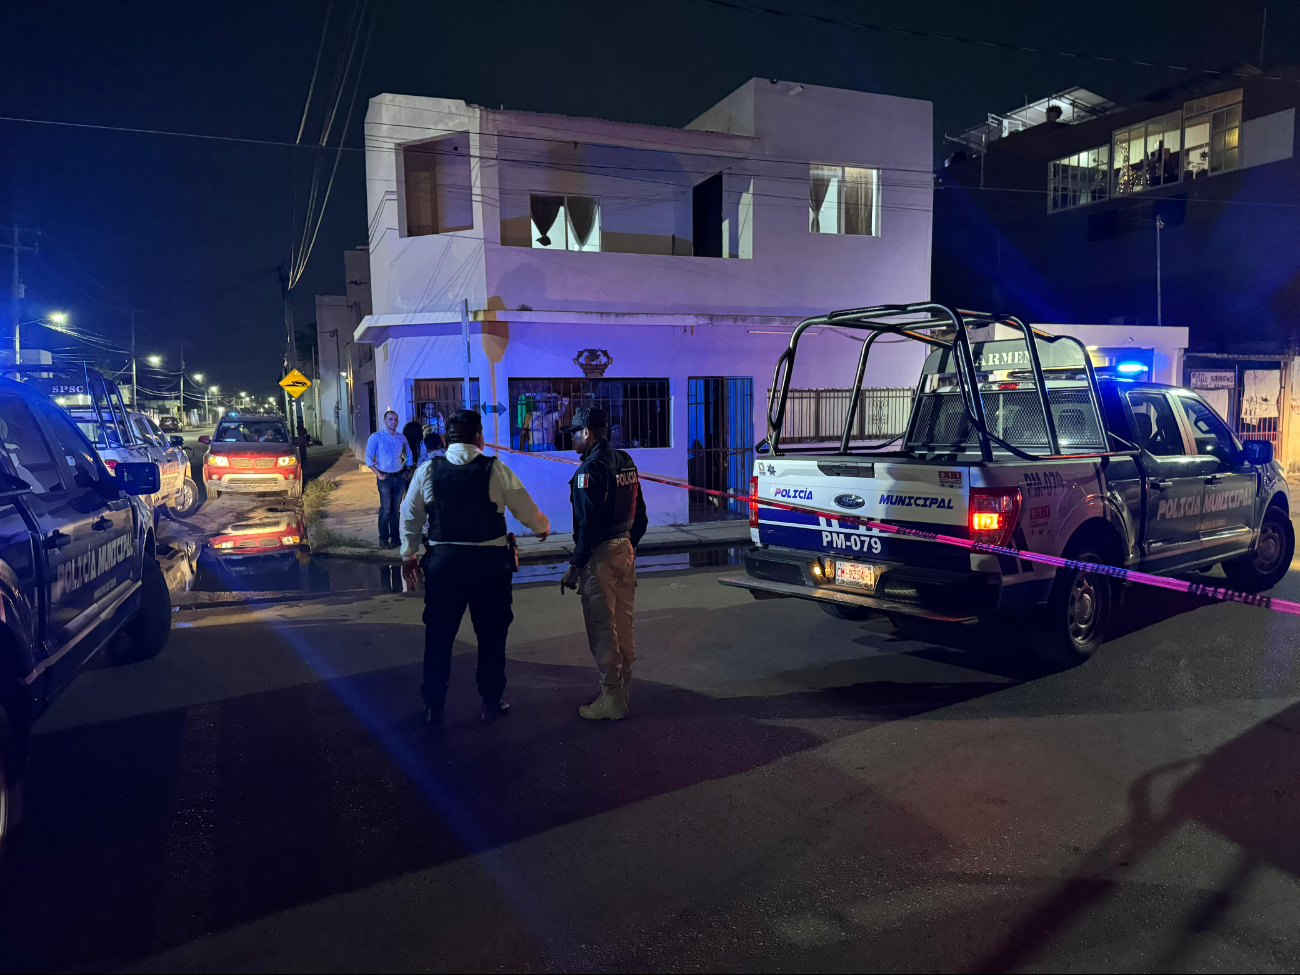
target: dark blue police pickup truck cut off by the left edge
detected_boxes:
[0,365,172,855]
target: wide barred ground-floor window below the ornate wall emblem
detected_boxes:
[510,377,672,451]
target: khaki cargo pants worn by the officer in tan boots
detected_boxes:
[577,538,637,688]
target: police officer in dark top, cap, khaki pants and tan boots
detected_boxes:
[560,407,646,720]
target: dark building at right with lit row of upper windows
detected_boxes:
[933,66,1300,465]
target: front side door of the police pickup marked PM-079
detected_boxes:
[1174,391,1260,560]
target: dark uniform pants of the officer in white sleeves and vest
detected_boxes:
[420,545,515,712]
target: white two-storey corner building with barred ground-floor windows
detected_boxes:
[354,79,933,530]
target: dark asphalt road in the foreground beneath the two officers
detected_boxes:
[0,546,1300,971]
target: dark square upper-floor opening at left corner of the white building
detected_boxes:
[400,133,475,237]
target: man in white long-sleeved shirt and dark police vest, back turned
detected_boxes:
[402,410,551,724]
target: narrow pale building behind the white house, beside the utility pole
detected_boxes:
[316,247,374,456]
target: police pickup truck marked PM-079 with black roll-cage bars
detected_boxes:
[722,303,1295,660]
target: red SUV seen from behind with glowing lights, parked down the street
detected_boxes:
[199,413,303,498]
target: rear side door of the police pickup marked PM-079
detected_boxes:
[1128,390,1206,571]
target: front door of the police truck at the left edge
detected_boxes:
[33,399,135,685]
